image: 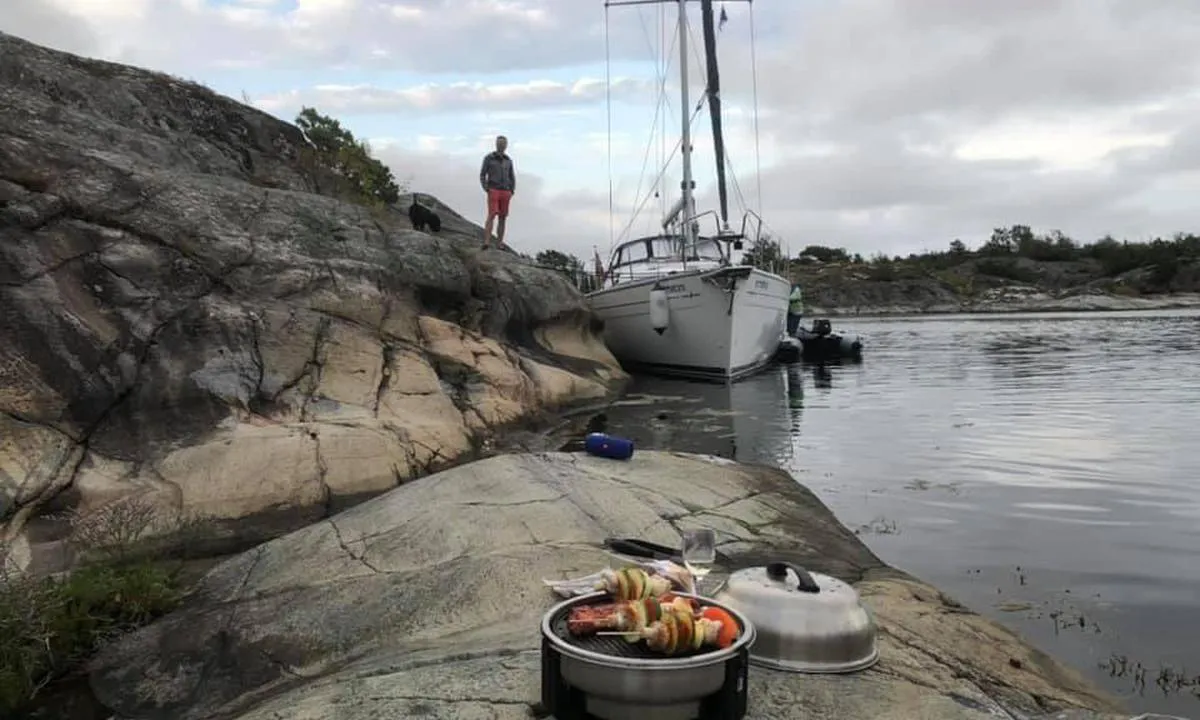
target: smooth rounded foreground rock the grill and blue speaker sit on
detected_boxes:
[91,451,1118,720]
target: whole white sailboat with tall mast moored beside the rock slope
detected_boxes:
[586,0,791,382]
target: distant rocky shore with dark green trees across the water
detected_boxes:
[782,224,1200,316]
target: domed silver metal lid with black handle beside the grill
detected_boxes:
[715,563,878,673]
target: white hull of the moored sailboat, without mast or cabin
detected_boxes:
[587,265,791,380]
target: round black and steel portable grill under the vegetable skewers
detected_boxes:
[541,593,755,720]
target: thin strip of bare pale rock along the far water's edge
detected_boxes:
[804,292,1200,318]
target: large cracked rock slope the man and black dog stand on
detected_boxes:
[0,34,625,569]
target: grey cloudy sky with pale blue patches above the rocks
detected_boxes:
[0,0,1200,257]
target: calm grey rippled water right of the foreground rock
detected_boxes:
[597,312,1200,718]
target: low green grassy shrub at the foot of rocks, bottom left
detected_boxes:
[0,503,182,718]
